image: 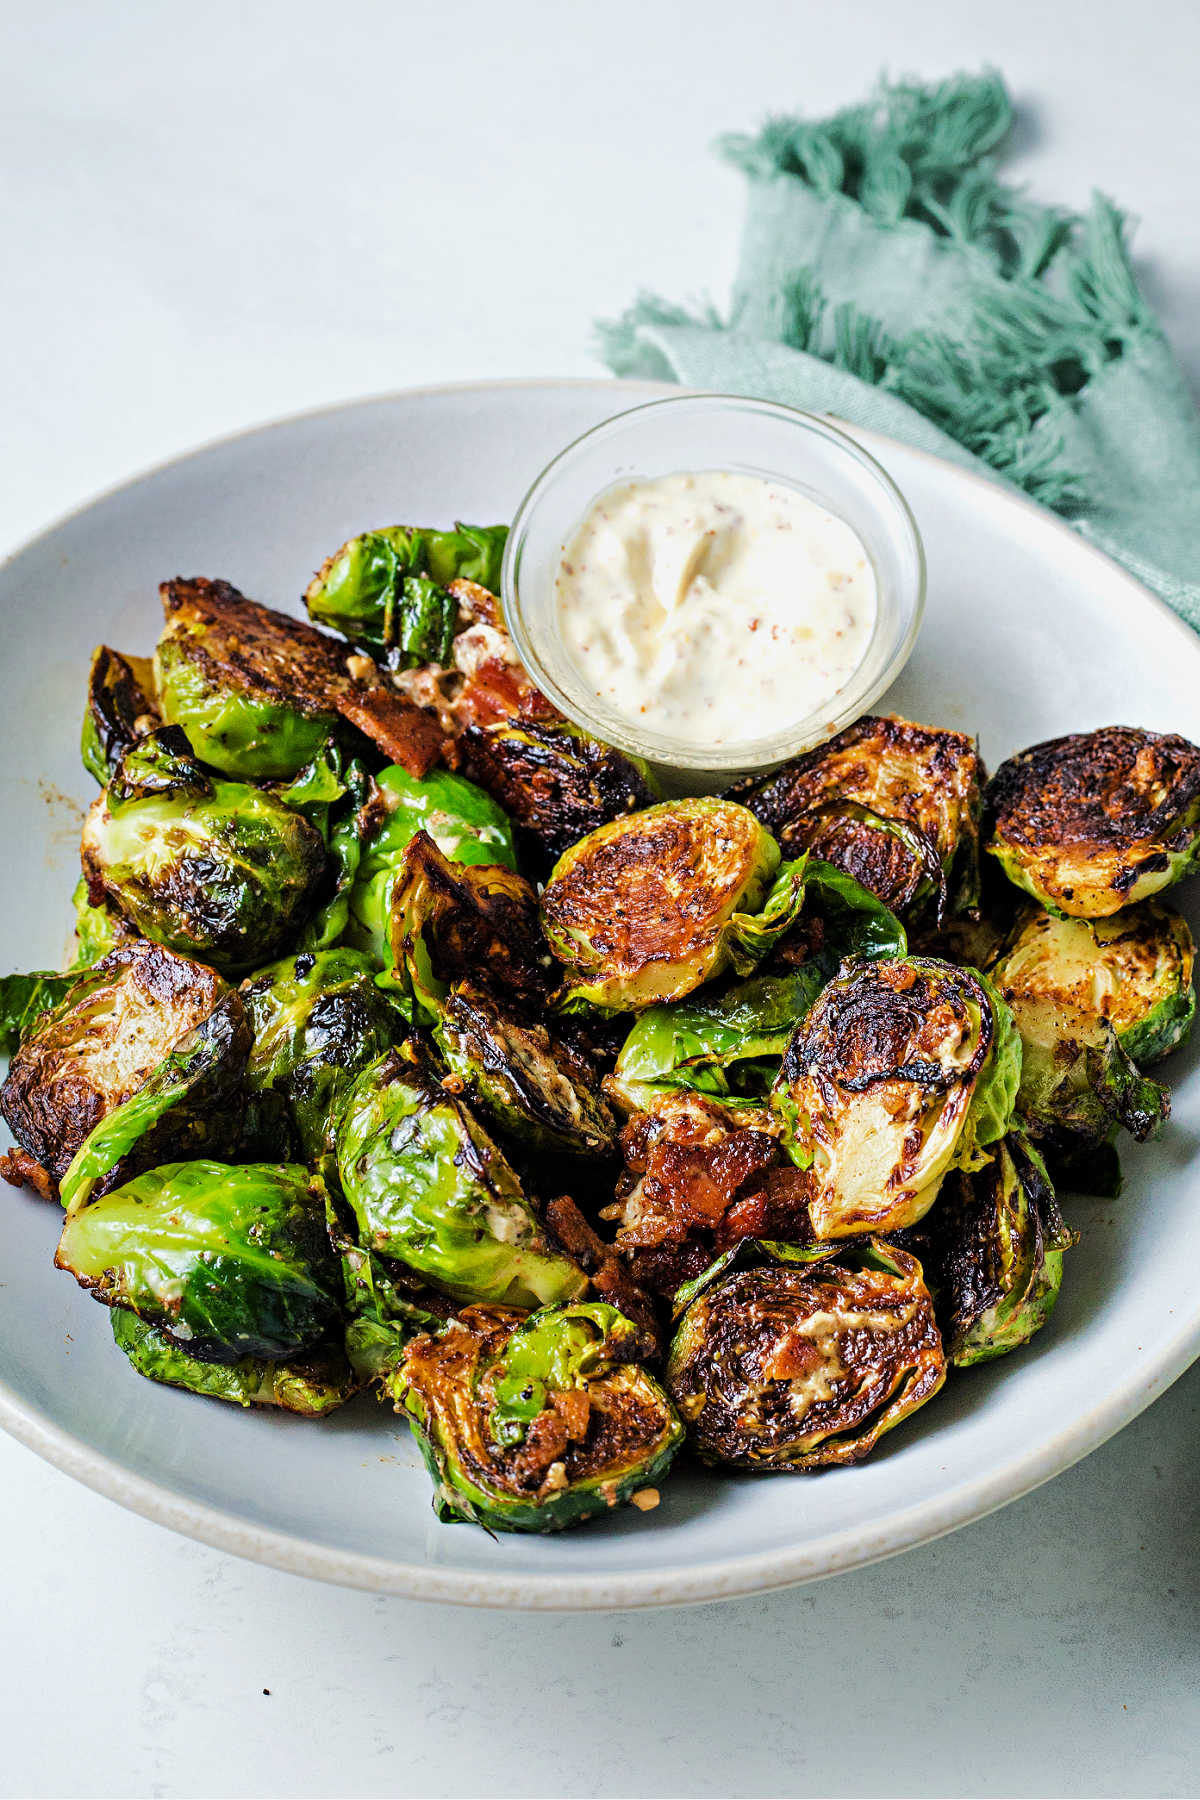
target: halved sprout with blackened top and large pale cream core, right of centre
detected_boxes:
[772,956,1020,1238]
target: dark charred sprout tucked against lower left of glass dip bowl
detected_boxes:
[461,720,657,857]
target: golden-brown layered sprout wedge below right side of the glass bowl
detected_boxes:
[729,716,981,918]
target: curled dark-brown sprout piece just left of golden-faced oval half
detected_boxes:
[380,832,551,1024]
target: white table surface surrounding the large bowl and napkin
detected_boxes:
[0,0,1200,1796]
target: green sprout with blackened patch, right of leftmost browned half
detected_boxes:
[241,950,405,1163]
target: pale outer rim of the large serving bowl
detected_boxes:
[0,376,1200,1611]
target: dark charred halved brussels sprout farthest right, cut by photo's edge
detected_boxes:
[988,725,1200,918]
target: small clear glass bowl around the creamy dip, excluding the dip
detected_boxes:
[502,394,925,790]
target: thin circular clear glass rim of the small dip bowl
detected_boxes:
[500,389,928,781]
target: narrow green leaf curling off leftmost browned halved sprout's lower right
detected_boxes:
[61,994,250,1213]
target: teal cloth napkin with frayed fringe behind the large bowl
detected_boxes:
[599,74,1200,628]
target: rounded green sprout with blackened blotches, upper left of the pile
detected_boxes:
[83,727,326,974]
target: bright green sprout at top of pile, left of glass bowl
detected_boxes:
[304,526,507,670]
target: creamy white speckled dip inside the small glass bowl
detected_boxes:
[554,468,876,745]
